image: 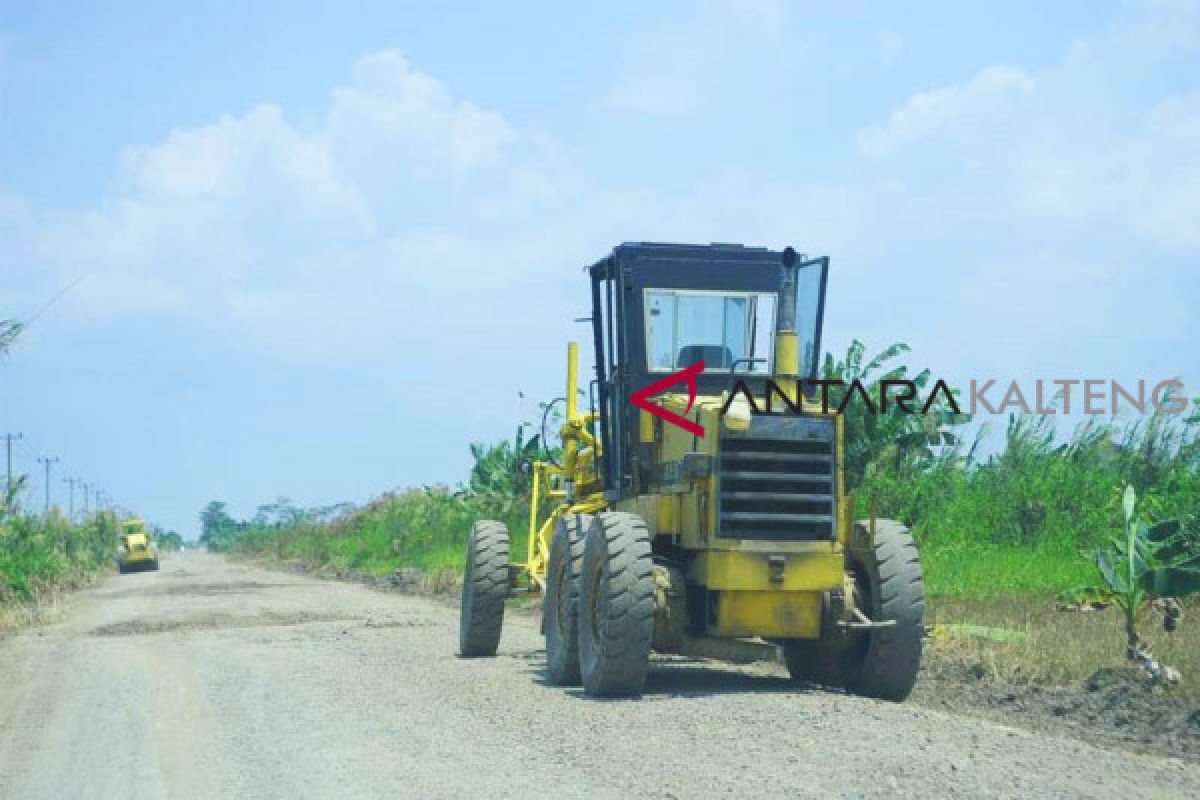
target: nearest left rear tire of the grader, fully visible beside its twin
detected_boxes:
[580,512,654,697]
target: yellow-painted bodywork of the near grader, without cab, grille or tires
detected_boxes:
[520,341,853,638]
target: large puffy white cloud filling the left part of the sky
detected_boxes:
[15,50,556,335]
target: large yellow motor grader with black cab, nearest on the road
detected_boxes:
[460,243,924,700]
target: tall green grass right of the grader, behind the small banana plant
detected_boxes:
[856,415,1200,596]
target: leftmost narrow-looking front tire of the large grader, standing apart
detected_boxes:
[458,519,509,658]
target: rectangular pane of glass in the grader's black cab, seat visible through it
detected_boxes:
[646,289,775,374]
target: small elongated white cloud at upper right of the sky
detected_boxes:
[858,66,1037,156]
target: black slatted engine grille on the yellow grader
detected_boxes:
[718,416,838,541]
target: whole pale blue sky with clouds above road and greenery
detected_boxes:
[0,0,1200,535]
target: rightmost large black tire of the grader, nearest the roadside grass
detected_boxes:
[844,519,925,702]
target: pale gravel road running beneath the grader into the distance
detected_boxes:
[0,553,1200,800]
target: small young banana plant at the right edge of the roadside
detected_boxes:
[1079,486,1200,682]
